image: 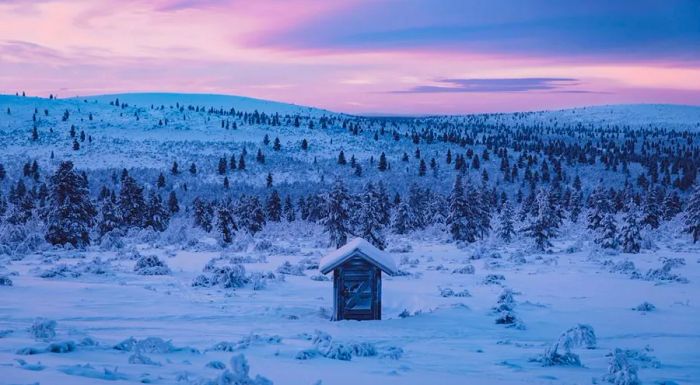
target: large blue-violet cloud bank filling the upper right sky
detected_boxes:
[253,0,700,61]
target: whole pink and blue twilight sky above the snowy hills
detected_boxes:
[0,0,700,114]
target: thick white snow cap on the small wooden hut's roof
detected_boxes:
[319,238,398,275]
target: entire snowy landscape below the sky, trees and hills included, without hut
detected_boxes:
[0,94,700,385]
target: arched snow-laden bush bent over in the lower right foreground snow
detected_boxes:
[539,324,596,366]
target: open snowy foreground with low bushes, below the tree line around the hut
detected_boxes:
[0,224,700,384]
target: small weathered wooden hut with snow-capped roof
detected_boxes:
[319,238,398,321]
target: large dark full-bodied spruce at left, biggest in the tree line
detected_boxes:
[46,162,96,247]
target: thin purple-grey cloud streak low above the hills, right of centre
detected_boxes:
[392,78,589,94]
